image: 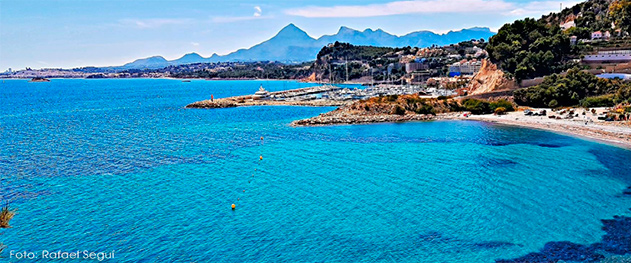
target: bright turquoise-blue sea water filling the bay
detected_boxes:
[0,79,631,262]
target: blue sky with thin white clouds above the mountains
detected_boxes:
[0,0,580,71]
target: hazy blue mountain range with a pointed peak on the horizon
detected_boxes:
[114,24,495,69]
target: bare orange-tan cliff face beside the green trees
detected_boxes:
[467,59,518,95]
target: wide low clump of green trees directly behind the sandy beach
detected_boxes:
[513,69,630,108]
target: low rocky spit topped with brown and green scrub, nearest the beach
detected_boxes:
[291,95,457,126]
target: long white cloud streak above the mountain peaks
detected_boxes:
[285,0,581,18]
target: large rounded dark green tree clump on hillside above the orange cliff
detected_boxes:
[486,18,571,81]
